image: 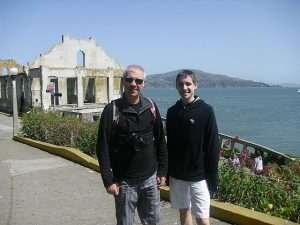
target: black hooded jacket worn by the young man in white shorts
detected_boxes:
[166,98,220,191]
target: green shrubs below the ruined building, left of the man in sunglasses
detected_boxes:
[21,108,98,157]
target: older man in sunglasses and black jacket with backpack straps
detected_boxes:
[97,65,168,225]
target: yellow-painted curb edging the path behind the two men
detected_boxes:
[13,136,296,225]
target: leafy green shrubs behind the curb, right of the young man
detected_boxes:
[218,163,300,223]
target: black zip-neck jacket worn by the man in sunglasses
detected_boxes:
[96,96,168,188]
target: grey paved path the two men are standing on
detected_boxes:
[0,114,228,225]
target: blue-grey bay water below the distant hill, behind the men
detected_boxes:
[143,88,300,156]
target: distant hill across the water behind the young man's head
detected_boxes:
[146,69,274,87]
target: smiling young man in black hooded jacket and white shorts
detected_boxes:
[166,70,220,225]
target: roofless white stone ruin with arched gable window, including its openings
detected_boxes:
[0,35,124,120]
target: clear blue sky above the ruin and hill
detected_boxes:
[0,0,300,84]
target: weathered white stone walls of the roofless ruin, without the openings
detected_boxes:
[0,35,124,112]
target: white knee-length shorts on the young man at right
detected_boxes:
[169,177,210,218]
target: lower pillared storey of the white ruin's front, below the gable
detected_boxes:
[40,66,124,109]
